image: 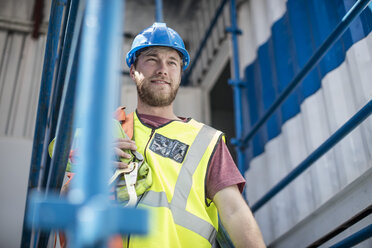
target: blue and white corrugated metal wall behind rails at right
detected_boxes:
[239,0,372,244]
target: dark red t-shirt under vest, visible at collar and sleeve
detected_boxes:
[137,113,245,199]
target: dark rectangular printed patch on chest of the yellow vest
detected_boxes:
[150,133,189,163]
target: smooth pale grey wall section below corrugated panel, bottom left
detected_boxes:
[0,137,32,248]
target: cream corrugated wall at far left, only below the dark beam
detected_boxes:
[0,30,45,139]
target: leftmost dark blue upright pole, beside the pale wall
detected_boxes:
[21,0,65,247]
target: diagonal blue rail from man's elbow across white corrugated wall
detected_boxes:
[251,100,372,212]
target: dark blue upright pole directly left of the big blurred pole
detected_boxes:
[46,0,83,194]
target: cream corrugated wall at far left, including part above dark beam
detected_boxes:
[0,0,51,139]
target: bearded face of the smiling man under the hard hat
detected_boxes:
[130,47,182,107]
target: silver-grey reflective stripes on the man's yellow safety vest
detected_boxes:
[141,125,217,243]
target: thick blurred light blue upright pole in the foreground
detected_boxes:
[70,0,145,247]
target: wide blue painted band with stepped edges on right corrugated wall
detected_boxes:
[243,0,372,158]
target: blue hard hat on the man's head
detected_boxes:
[126,22,190,70]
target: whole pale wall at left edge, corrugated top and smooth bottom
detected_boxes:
[0,0,50,248]
